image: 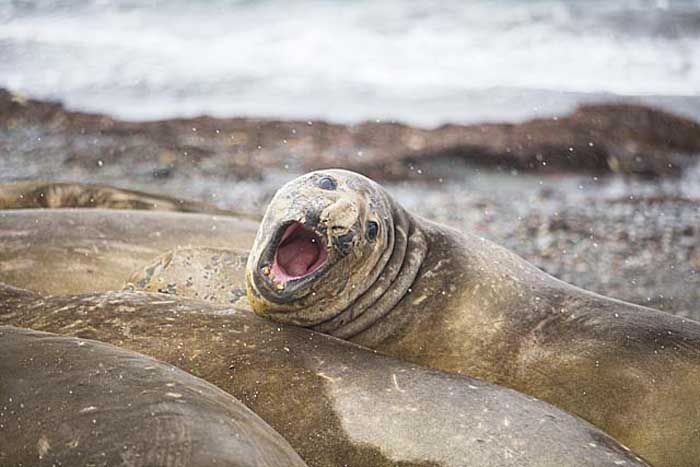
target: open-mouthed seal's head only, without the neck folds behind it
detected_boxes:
[246,170,394,326]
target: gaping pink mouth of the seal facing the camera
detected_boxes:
[272,222,328,284]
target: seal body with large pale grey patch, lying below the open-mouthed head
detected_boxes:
[0,286,647,467]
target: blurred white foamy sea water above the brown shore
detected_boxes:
[0,0,700,126]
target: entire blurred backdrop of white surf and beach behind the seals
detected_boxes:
[0,0,700,318]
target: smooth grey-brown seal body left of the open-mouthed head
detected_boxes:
[0,209,258,294]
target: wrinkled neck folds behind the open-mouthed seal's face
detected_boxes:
[312,201,428,339]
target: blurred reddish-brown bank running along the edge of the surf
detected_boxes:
[0,90,700,180]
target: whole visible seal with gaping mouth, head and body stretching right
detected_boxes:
[246,170,700,467]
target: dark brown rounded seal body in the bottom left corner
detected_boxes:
[0,326,306,467]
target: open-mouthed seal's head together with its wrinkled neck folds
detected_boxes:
[246,170,427,338]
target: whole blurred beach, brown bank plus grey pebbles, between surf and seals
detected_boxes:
[0,91,700,319]
